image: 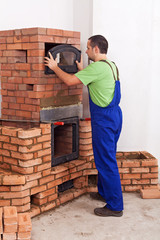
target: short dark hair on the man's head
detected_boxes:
[88,35,108,54]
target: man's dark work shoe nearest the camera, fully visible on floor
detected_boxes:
[94,206,123,217]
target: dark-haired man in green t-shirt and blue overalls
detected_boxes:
[45,35,123,217]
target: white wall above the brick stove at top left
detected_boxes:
[0,0,74,30]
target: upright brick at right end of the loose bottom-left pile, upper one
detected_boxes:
[18,213,32,233]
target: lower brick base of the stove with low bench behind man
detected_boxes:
[0,121,158,217]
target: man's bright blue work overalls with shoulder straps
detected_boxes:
[89,61,123,211]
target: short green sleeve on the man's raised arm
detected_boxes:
[75,63,97,86]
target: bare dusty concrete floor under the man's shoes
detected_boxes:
[32,193,160,240]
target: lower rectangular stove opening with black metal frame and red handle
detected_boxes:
[51,117,79,166]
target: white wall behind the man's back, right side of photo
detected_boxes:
[93,0,160,161]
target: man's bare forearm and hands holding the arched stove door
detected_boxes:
[45,52,83,86]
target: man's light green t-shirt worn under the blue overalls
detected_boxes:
[75,59,117,107]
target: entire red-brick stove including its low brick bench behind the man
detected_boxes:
[0,28,158,217]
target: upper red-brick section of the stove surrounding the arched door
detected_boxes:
[0,28,82,124]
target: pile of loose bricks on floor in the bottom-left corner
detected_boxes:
[0,206,32,240]
